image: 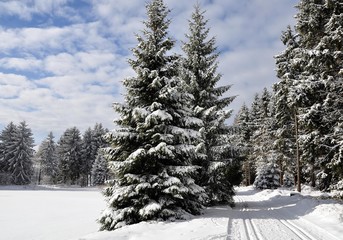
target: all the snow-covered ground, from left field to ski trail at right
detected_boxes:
[0,187,343,240]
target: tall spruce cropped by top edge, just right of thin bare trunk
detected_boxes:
[295,0,329,190]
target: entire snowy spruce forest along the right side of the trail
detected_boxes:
[235,0,343,191]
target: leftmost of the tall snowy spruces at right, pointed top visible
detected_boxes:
[273,26,299,186]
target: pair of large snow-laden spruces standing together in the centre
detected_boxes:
[100,0,239,230]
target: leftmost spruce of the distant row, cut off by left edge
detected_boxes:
[0,122,17,184]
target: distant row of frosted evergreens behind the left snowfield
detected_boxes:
[0,122,108,185]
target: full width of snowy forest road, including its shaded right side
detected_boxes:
[227,188,343,240]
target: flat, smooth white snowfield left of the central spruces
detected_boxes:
[0,186,106,240]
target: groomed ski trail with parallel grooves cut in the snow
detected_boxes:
[230,190,340,240]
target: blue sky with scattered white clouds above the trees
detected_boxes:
[0,0,298,144]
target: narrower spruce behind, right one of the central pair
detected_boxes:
[180,5,237,204]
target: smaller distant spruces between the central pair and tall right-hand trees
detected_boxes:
[234,88,295,189]
